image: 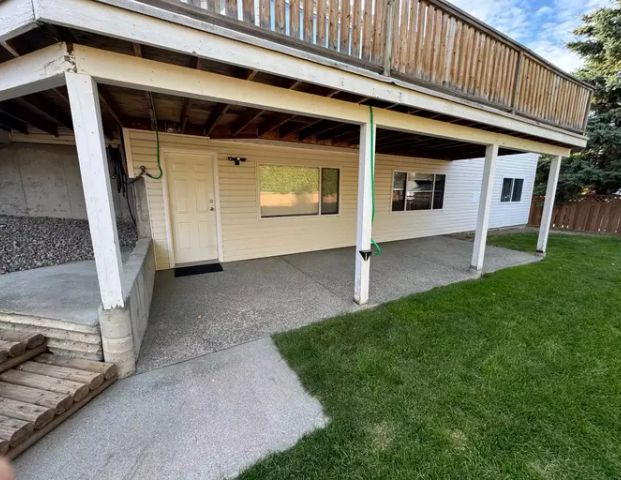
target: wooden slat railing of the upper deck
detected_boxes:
[170,0,591,132]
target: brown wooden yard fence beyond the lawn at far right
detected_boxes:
[528,195,621,234]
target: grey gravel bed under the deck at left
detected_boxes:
[0,215,137,275]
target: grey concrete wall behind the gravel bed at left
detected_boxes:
[0,143,130,220]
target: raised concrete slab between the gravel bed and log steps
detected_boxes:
[0,247,131,327]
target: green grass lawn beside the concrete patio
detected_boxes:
[241,234,621,480]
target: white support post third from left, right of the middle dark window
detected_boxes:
[470,145,498,272]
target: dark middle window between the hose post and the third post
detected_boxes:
[392,172,446,212]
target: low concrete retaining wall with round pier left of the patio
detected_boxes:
[99,239,155,377]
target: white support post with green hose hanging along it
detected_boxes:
[354,123,375,305]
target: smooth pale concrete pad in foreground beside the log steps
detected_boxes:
[15,339,327,480]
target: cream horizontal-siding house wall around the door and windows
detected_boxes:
[125,130,537,269]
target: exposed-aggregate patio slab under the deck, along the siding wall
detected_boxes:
[138,237,537,371]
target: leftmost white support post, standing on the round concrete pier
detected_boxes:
[65,73,124,310]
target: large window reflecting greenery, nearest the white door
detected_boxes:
[259,165,340,218]
